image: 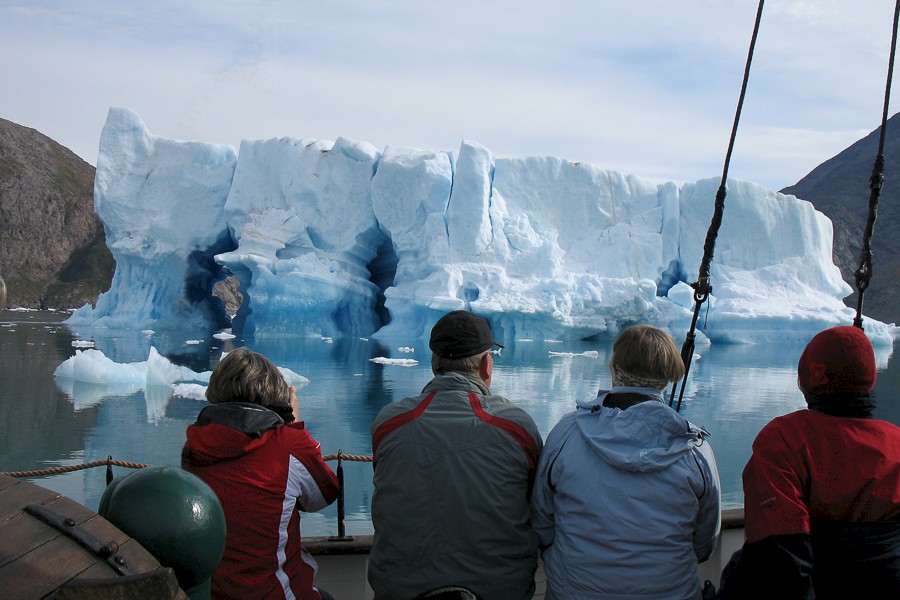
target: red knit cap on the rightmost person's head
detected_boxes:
[797,325,875,396]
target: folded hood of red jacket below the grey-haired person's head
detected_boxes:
[182,402,284,466]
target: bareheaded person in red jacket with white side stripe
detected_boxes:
[181,348,339,600]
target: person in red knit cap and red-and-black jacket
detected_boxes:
[718,326,900,600]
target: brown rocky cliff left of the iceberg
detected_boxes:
[0,119,115,308]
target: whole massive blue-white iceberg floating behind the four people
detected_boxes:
[68,108,895,344]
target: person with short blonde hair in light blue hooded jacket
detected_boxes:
[532,325,721,600]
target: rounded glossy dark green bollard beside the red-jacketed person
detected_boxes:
[97,467,225,600]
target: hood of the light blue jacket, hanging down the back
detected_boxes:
[575,388,705,472]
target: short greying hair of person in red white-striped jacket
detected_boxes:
[206,347,291,406]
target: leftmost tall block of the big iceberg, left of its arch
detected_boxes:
[69,111,237,329]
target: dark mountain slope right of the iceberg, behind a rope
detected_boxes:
[780,114,900,323]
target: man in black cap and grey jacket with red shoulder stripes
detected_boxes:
[368,310,543,600]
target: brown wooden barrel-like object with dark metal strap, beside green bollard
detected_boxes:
[0,475,187,600]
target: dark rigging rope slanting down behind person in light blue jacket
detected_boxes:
[669,0,768,412]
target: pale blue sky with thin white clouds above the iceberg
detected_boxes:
[0,0,900,190]
